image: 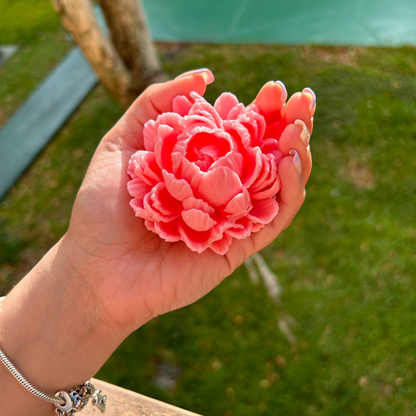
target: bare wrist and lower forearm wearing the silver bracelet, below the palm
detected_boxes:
[0,236,127,415]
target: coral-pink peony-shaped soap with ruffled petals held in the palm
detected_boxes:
[127,82,315,254]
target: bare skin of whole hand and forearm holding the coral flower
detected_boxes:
[0,71,313,416]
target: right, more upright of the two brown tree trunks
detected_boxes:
[99,0,165,94]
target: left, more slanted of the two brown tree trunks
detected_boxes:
[53,0,137,107]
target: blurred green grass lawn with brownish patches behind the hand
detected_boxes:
[0,0,416,416]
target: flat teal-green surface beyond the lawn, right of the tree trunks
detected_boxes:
[143,0,416,46]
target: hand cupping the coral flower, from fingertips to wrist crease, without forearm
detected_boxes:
[63,73,314,332]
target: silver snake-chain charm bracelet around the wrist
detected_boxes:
[0,342,107,416]
